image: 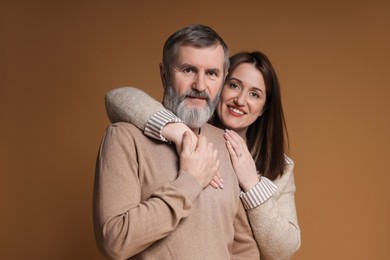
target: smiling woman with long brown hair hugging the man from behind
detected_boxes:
[106,52,301,259]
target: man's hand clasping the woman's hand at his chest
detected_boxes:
[180,131,220,188]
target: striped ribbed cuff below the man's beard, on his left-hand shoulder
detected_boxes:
[144,109,182,142]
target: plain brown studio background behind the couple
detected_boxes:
[0,0,390,259]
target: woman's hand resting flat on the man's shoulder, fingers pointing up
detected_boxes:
[224,130,259,191]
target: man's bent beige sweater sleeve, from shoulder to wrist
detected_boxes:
[94,124,202,259]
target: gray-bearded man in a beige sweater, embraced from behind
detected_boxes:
[94,25,259,260]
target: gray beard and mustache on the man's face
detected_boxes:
[163,85,220,129]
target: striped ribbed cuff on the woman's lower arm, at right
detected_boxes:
[240,177,278,209]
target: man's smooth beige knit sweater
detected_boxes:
[93,123,259,260]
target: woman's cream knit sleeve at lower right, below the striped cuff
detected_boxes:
[247,160,301,260]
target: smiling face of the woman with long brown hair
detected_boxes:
[217,63,266,132]
